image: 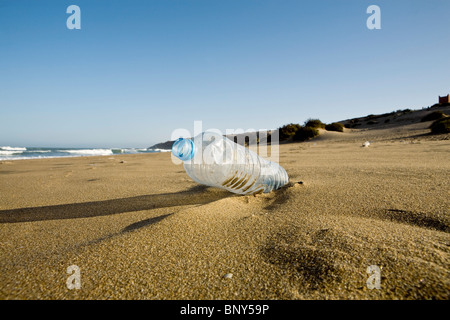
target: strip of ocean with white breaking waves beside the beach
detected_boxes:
[0,146,171,160]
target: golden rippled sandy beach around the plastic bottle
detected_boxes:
[0,115,450,299]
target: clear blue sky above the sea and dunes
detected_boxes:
[0,0,450,147]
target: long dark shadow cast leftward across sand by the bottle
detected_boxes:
[0,185,233,224]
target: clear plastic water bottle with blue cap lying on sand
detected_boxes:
[172,132,289,195]
